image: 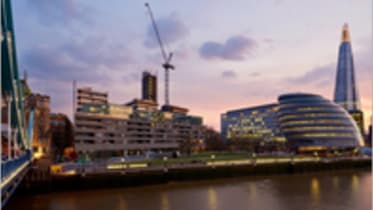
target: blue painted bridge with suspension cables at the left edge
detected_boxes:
[0,0,33,207]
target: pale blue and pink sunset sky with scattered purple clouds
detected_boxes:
[12,0,372,130]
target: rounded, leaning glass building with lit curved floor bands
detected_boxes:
[277,93,363,152]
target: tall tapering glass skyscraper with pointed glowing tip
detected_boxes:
[334,24,364,135]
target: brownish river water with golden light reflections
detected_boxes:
[5,170,372,210]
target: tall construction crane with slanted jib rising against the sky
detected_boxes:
[145,3,175,105]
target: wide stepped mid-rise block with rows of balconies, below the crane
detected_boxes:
[74,86,203,157]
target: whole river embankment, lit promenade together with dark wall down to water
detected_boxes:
[20,156,371,193]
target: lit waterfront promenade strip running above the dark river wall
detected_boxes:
[51,155,371,176]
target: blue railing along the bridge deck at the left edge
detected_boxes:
[1,150,31,180]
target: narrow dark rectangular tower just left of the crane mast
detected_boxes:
[142,71,157,102]
